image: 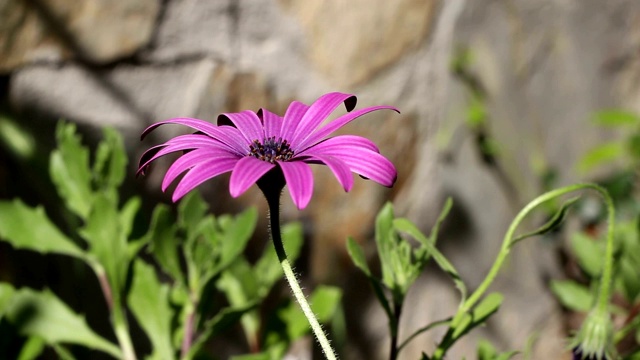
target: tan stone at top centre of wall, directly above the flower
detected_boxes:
[280,0,436,87]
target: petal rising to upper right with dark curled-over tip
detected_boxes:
[287,92,357,149]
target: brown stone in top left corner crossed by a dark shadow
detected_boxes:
[0,0,159,71]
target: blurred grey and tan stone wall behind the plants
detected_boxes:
[0,0,640,359]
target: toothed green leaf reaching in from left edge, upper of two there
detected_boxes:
[0,199,85,259]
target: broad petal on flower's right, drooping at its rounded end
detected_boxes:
[306,137,397,187]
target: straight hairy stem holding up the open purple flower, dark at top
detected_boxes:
[263,189,338,360]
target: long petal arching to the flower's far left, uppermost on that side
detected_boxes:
[141,118,249,155]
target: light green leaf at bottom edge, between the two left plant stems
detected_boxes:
[128,260,175,359]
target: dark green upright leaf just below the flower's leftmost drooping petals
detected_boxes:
[145,204,184,281]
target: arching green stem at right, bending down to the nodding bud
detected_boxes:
[433,184,615,359]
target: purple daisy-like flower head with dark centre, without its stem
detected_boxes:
[138,92,399,209]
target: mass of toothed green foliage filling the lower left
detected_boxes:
[0,122,341,360]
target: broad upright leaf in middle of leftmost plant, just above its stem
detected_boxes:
[79,193,129,296]
